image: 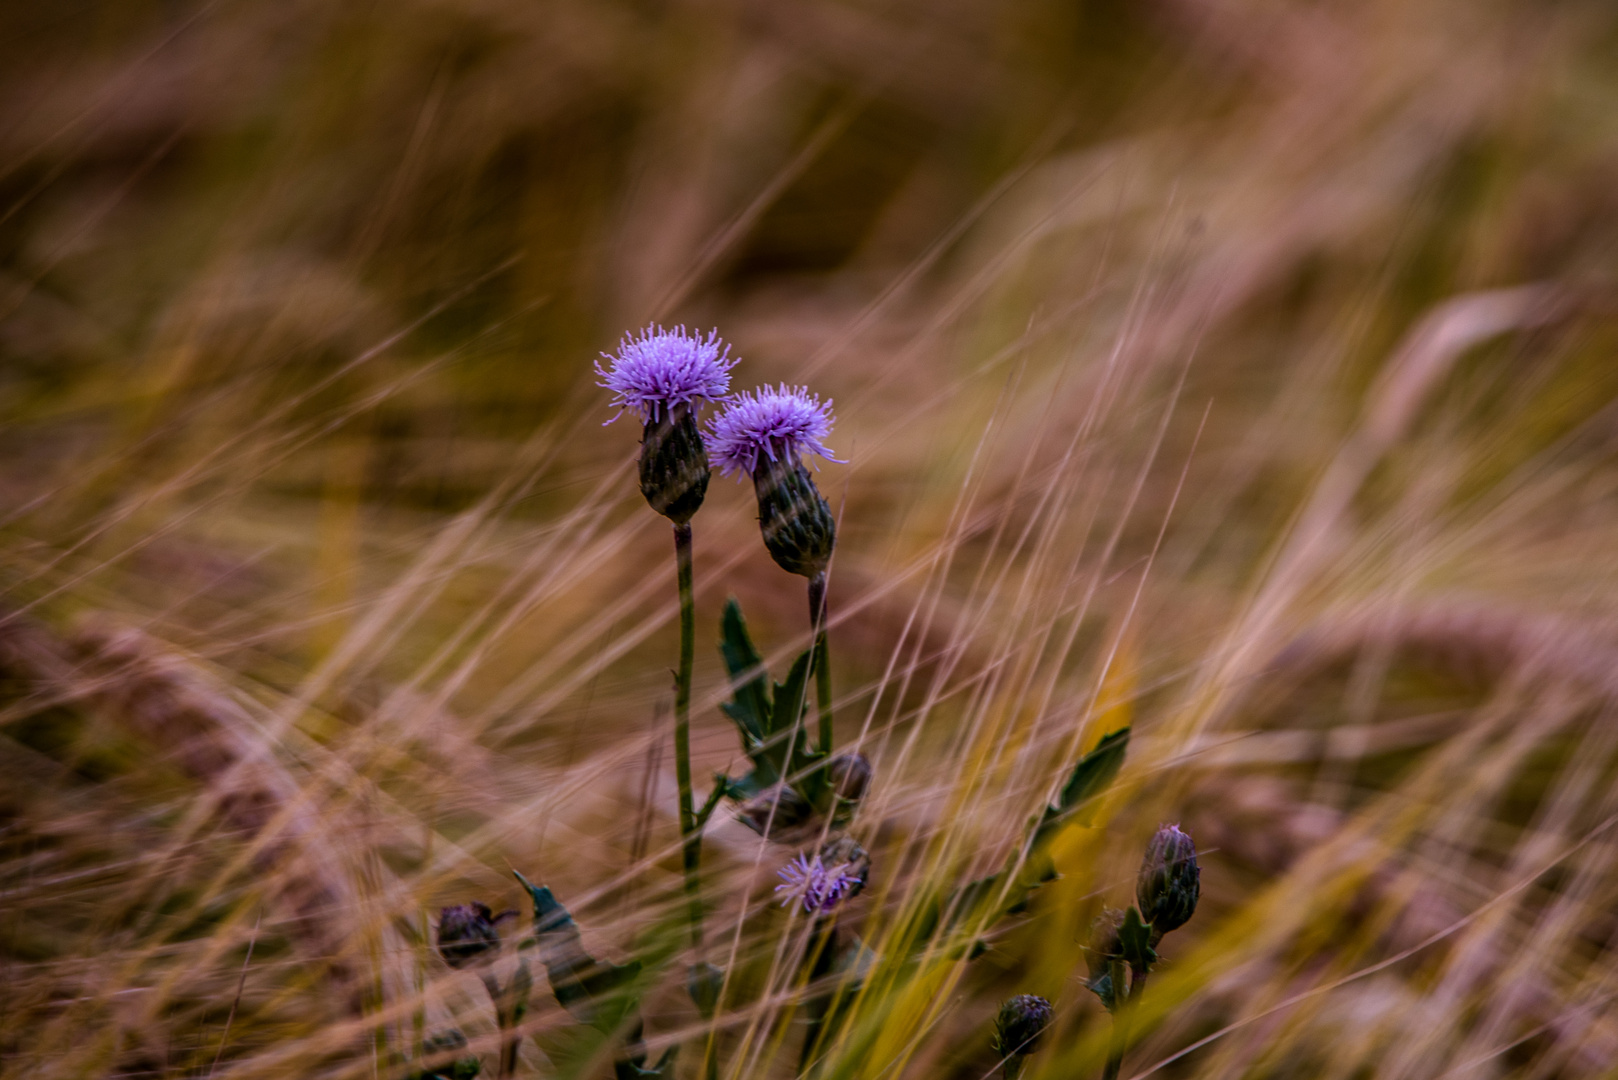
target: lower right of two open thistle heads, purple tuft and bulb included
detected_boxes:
[709,385,837,578]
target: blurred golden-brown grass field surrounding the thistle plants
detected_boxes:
[0,0,1618,1080]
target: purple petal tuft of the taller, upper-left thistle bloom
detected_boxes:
[595,325,736,424]
